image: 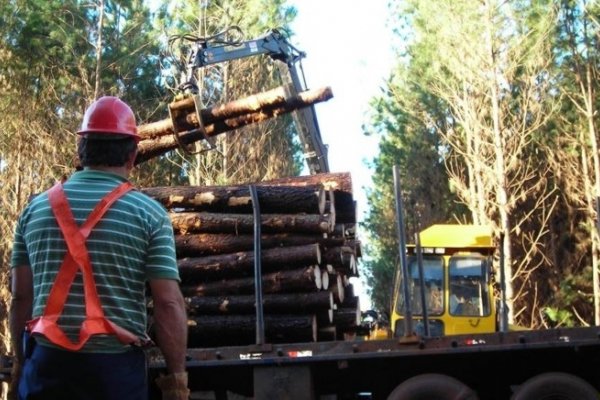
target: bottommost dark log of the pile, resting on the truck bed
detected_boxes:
[188,315,317,347]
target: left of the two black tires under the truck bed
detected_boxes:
[387,374,479,400]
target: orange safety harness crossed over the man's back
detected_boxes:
[27,182,145,351]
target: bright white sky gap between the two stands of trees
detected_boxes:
[287,0,394,310]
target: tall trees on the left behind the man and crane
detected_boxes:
[0,0,300,360]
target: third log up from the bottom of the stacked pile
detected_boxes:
[181,266,324,297]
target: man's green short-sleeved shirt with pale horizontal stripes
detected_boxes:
[11,170,179,352]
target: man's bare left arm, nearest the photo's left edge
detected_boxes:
[9,265,33,361]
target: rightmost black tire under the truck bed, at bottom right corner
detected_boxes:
[511,372,600,400]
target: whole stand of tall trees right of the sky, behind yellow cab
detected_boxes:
[363,0,600,326]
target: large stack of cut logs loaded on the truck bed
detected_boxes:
[142,173,360,347]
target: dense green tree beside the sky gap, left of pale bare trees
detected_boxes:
[362,7,465,312]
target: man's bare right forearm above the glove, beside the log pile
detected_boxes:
[150,279,187,373]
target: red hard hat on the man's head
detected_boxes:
[77,96,141,142]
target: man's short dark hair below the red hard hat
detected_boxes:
[77,136,137,167]
